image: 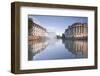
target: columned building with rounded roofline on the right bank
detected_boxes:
[64,23,88,39]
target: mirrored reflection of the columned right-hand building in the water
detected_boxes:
[62,40,88,58]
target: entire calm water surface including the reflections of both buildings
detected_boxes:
[28,39,88,60]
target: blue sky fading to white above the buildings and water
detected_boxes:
[28,15,88,35]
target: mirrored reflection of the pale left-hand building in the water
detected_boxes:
[28,40,48,60]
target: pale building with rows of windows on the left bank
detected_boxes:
[28,19,47,40]
